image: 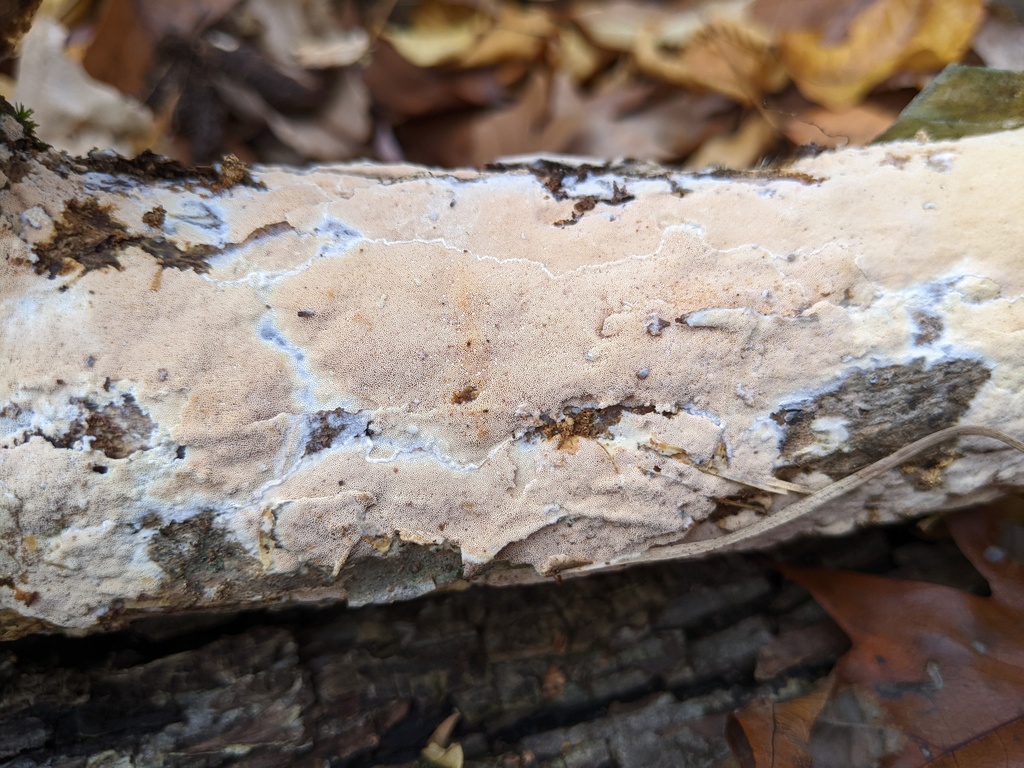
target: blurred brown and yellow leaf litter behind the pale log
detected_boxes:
[0,0,1024,168]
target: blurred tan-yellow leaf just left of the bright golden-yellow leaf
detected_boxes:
[633,0,787,104]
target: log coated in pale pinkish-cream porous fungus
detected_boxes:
[0,119,1024,635]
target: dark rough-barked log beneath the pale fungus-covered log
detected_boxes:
[0,527,980,768]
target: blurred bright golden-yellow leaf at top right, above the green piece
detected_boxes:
[779,0,984,109]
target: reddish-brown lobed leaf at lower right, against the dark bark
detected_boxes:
[730,500,1024,768]
